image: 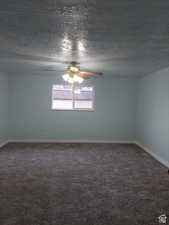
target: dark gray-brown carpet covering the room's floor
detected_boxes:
[0,144,169,225]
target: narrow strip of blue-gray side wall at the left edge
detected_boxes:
[0,72,8,142]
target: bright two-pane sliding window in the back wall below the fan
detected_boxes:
[52,85,94,110]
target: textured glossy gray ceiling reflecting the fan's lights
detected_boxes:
[0,0,169,76]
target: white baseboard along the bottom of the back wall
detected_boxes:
[9,139,135,144]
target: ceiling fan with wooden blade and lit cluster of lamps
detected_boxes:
[62,62,103,84]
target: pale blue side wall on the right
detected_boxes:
[137,68,169,162]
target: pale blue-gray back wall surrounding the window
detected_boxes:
[9,74,138,141]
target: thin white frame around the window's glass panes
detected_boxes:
[51,84,95,112]
